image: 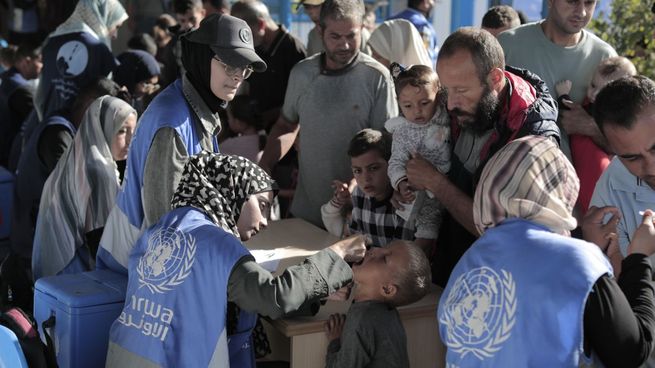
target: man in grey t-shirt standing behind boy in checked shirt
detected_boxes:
[260,0,398,226]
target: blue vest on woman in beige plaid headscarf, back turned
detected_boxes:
[437,219,612,368]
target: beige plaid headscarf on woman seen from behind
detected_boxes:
[473,136,580,235]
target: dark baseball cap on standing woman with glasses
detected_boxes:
[182,14,266,72]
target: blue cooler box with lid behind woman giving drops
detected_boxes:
[34,270,127,368]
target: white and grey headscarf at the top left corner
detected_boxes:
[49,0,128,50]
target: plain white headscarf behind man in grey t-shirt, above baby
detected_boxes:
[368,19,434,69]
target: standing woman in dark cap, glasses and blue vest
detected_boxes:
[97,14,266,273]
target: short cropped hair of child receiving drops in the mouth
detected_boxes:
[390,240,432,307]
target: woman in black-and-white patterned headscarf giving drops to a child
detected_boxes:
[106,152,365,368]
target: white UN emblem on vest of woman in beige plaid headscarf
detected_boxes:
[439,267,516,360]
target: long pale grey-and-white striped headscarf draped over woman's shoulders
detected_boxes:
[32,96,136,280]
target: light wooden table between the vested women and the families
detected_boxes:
[246,219,445,368]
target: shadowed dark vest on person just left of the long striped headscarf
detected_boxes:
[10,115,77,259]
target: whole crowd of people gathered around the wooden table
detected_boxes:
[0,0,655,367]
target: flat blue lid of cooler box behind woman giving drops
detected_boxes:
[35,270,127,308]
